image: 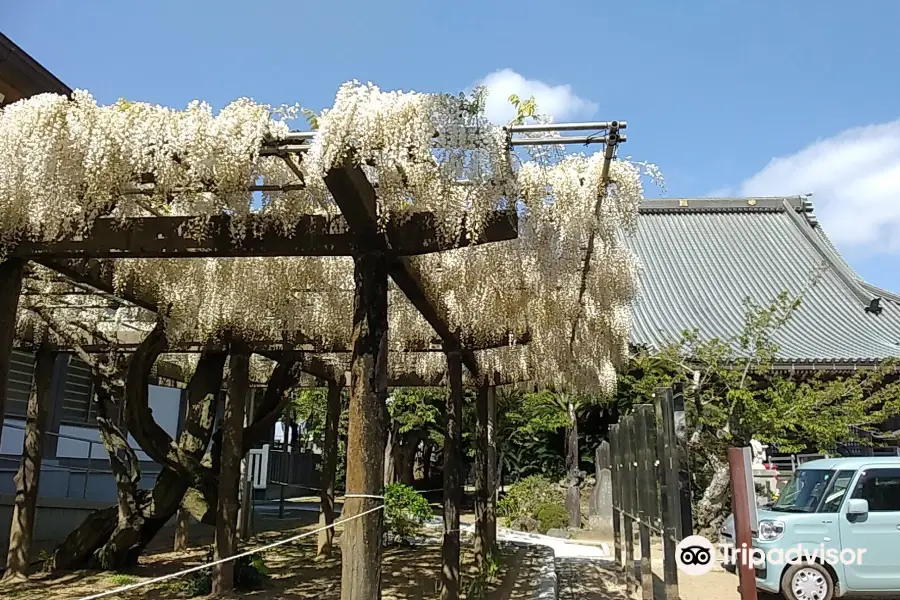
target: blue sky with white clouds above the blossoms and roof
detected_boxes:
[0,0,900,291]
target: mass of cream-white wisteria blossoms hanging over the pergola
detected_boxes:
[0,82,652,392]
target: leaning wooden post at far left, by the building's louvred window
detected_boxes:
[3,345,57,580]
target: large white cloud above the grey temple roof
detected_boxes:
[739,120,900,254]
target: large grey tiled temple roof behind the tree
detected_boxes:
[627,197,900,363]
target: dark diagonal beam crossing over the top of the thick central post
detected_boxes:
[325,159,502,377]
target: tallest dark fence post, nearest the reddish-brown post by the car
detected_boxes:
[654,388,681,600]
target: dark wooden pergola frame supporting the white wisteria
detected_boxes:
[0,121,625,600]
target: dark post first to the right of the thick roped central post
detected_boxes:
[441,350,462,600]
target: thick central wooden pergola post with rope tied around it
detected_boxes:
[341,252,388,600]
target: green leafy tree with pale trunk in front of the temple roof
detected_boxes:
[618,292,900,533]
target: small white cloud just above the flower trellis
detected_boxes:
[476,69,597,124]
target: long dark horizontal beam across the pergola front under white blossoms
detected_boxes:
[10,211,517,259]
